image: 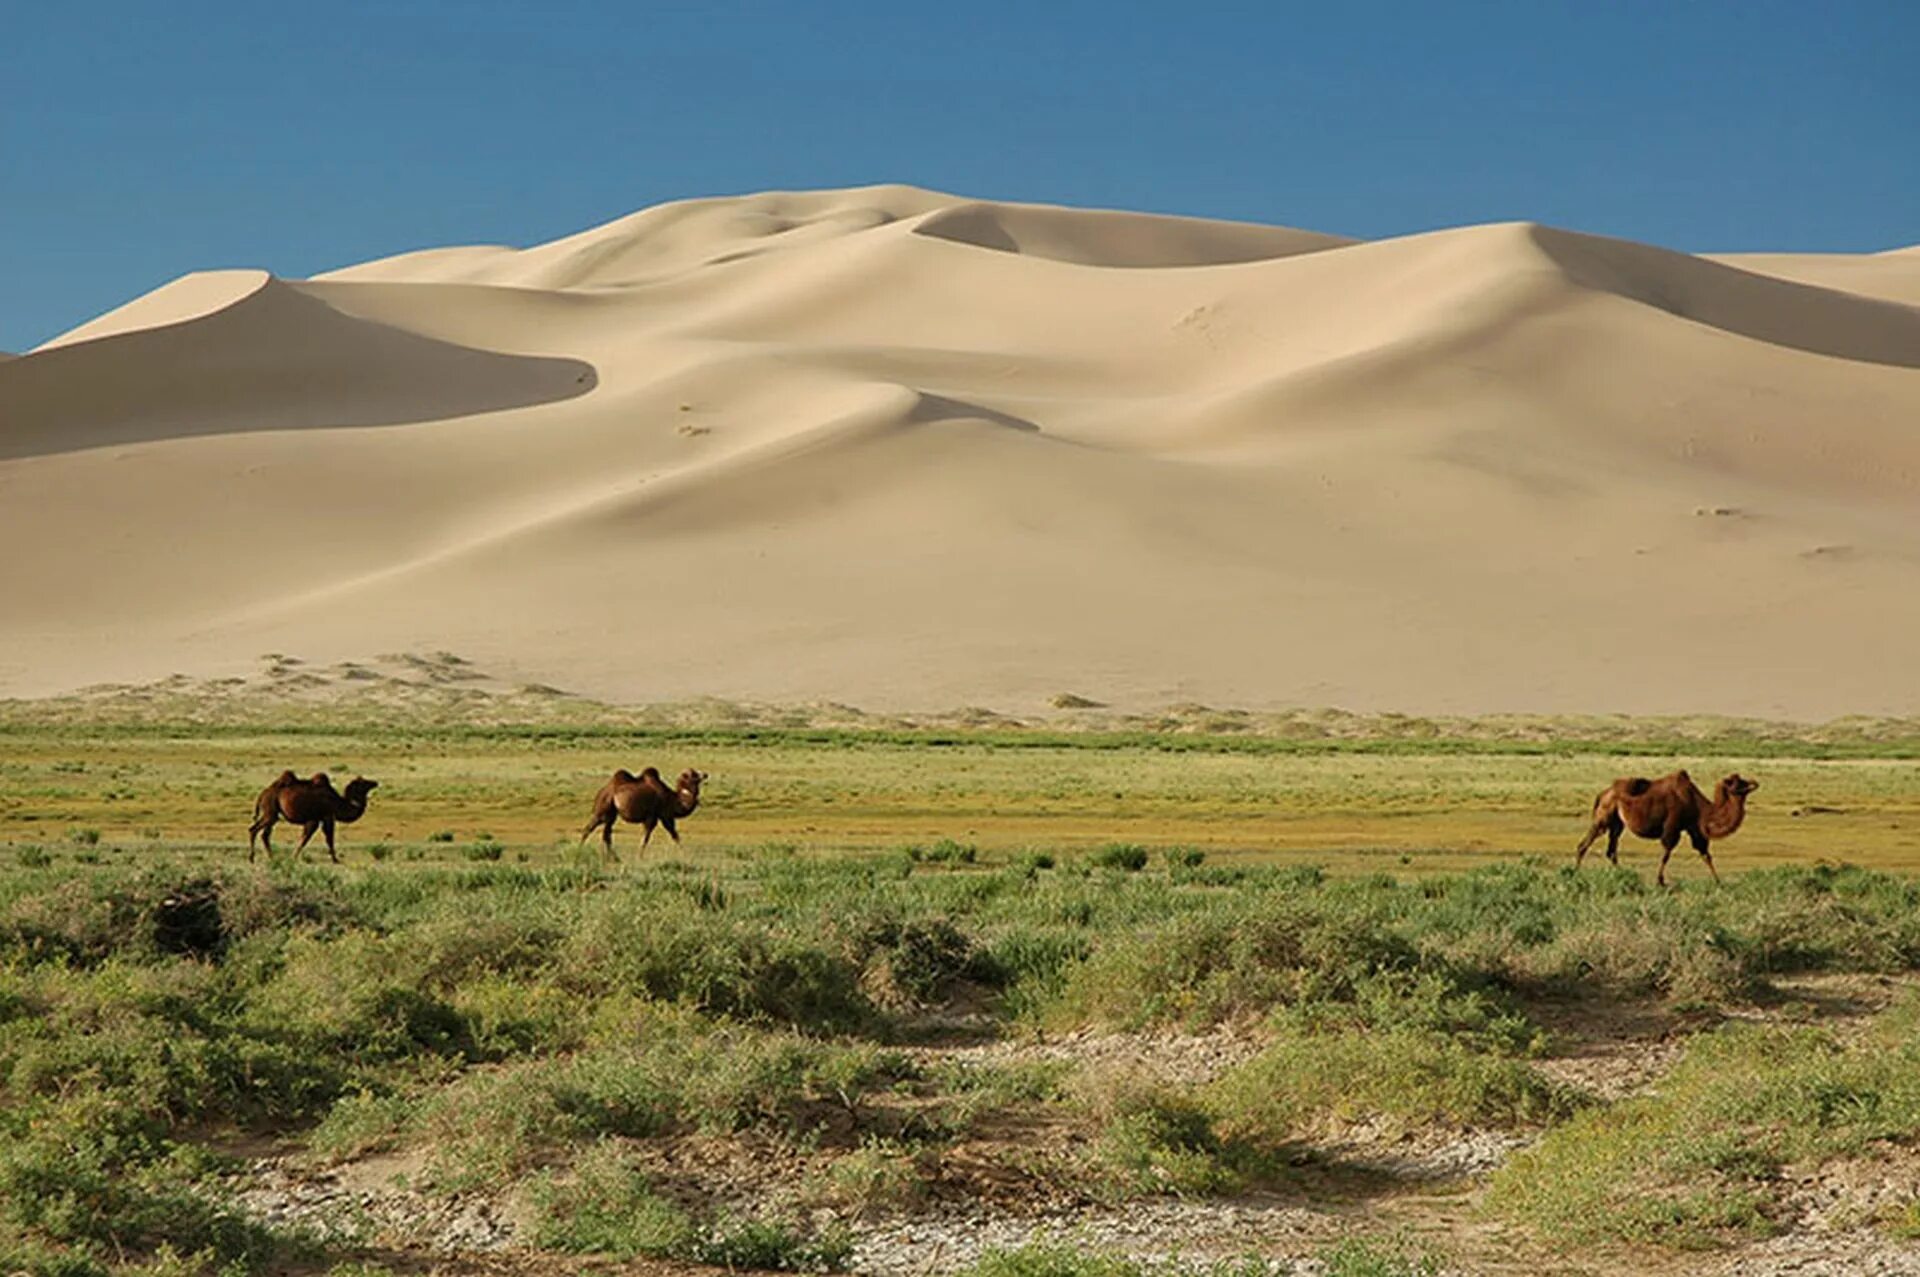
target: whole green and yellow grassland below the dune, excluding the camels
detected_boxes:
[0,691,1920,1277]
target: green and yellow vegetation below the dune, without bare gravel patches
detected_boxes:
[0,710,1920,1277]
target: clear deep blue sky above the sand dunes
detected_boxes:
[0,0,1920,351]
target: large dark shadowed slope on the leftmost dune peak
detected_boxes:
[0,280,599,459]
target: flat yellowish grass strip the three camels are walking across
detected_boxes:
[0,724,1920,874]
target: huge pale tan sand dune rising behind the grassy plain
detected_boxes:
[0,186,1920,716]
